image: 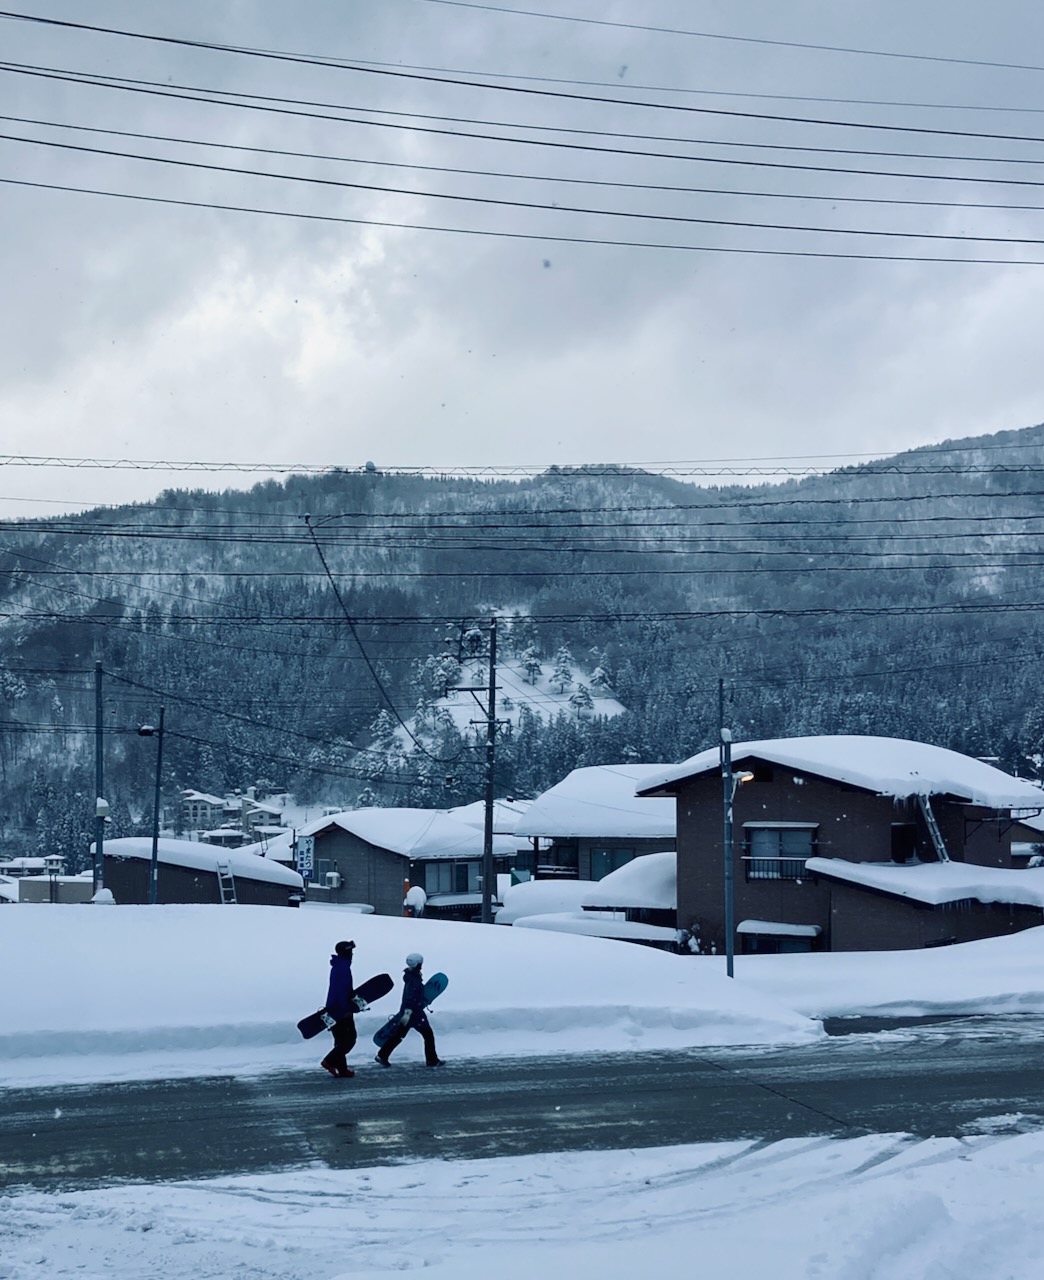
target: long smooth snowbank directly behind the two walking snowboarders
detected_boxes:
[0,904,821,1084]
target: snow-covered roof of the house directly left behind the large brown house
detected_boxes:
[514,764,677,840]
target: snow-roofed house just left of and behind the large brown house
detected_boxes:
[514,764,676,881]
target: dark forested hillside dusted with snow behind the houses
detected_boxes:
[0,426,1044,858]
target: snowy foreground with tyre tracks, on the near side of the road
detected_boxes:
[0,1131,1044,1280]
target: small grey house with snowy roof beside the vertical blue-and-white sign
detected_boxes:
[298,809,527,920]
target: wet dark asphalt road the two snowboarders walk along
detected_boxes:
[0,1018,1044,1190]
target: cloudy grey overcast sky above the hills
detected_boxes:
[0,0,1044,516]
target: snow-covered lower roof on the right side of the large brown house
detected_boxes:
[805,858,1044,906]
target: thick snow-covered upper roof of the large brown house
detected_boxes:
[638,733,1044,810]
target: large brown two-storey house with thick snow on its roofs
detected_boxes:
[637,735,1044,952]
